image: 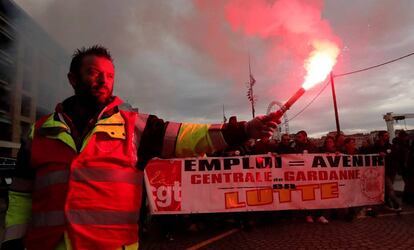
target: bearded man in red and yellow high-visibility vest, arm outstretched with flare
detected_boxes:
[2,46,277,250]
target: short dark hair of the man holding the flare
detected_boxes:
[69,44,113,75]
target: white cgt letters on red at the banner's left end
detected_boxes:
[151,181,181,211]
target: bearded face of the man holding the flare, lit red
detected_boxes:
[71,55,115,105]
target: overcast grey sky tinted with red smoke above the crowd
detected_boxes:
[15,0,414,136]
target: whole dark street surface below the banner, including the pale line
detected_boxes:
[140,206,414,250]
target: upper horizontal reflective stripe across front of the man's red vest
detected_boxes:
[35,168,142,190]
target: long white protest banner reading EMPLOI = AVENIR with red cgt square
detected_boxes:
[145,154,384,214]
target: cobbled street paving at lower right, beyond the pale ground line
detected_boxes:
[205,211,414,249]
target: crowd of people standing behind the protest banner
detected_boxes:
[256,130,414,211]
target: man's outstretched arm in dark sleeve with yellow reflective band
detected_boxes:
[138,115,277,168]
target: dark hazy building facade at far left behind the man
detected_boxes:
[0,0,70,157]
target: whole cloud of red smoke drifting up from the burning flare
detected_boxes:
[188,0,340,95]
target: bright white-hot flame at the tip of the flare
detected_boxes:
[302,41,339,90]
